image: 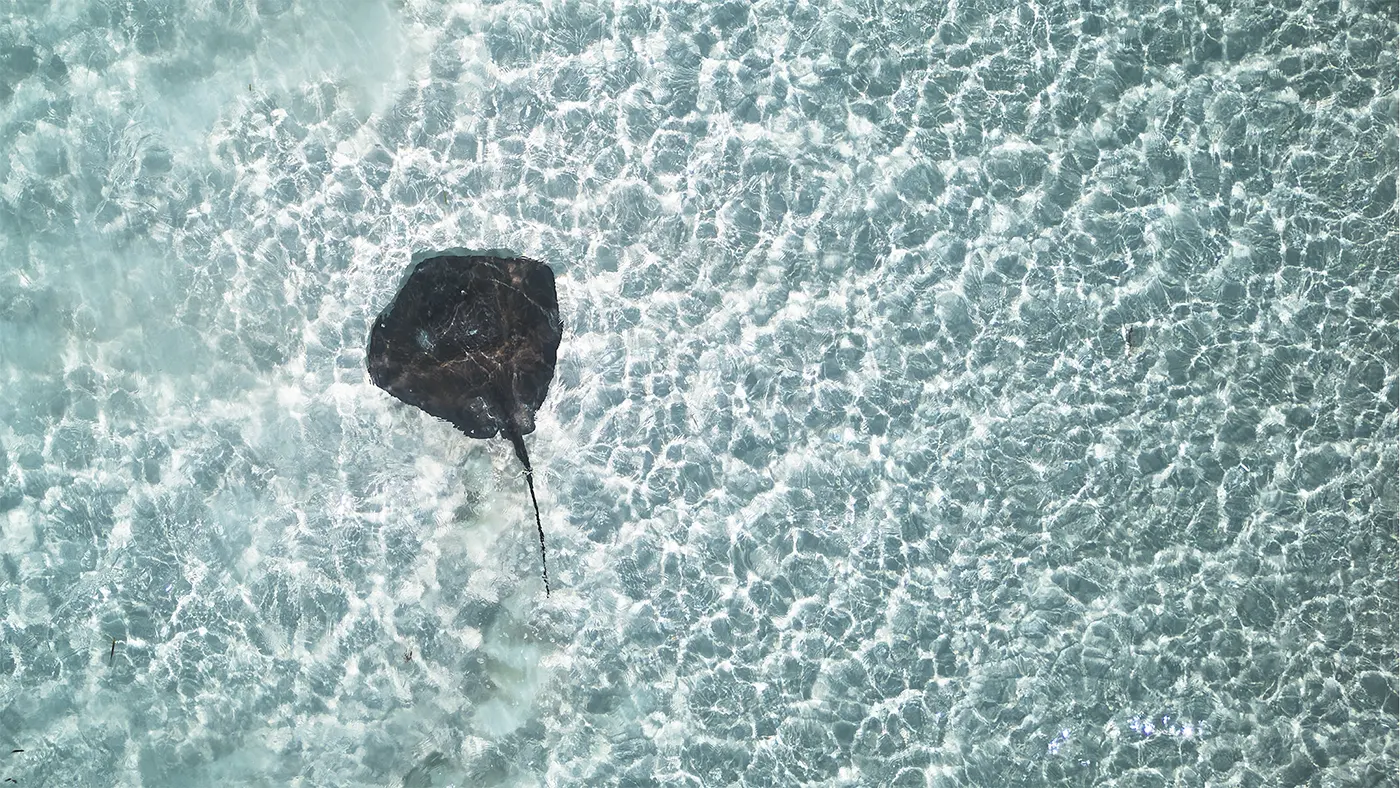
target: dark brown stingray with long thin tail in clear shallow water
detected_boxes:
[368,255,563,596]
